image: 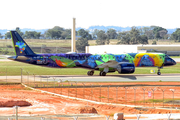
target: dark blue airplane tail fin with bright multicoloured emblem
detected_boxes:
[10,31,35,56]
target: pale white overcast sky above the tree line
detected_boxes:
[0,0,180,30]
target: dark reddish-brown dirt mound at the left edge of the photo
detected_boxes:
[0,100,31,107]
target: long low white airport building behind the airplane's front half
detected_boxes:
[86,45,180,56]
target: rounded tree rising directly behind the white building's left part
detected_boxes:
[96,30,109,45]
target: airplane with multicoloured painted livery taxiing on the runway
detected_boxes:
[8,31,176,76]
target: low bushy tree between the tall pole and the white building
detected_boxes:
[76,37,89,52]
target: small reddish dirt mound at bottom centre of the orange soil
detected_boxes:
[79,106,98,114]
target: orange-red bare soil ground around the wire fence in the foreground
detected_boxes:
[0,82,180,115]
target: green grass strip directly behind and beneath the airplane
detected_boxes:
[0,61,180,76]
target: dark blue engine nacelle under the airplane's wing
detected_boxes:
[116,63,135,74]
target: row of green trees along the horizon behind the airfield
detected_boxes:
[0,26,180,51]
